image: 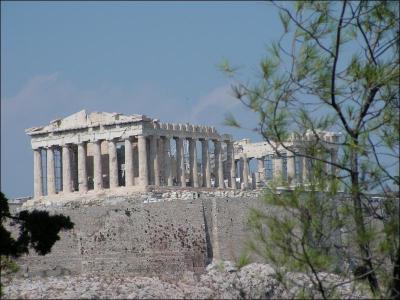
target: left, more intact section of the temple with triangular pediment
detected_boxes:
[26,110,233,198]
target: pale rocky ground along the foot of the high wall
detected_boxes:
[2,261,370,299]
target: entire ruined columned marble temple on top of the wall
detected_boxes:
[26,110,338,198]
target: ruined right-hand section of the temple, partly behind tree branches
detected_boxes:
[234,130,340,188]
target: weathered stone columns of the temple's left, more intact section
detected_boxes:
[34,135,236,197]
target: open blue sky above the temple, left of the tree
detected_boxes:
[1,1,281,198]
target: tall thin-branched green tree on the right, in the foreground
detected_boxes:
[223,1,400,298]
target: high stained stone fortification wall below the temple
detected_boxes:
[7,191,264,276]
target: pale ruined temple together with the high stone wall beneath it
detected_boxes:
[12,110,339,276]
